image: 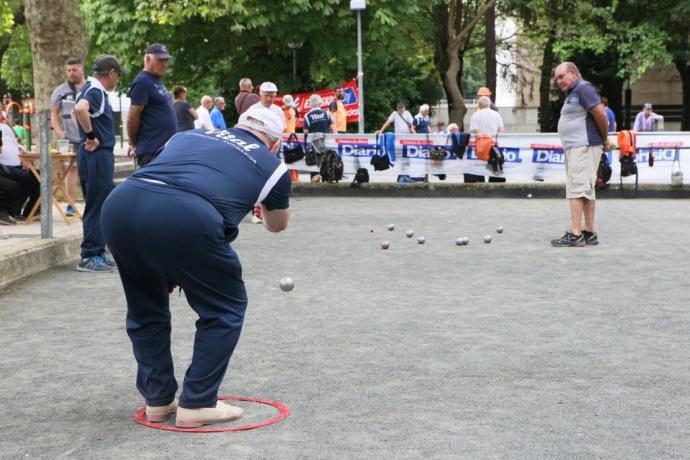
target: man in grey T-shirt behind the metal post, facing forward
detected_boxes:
[50,58,86,217]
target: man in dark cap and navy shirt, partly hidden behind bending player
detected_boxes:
[127,43,177,166]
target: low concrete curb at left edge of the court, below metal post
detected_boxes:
[0,234,82,289]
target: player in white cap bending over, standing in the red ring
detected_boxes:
[102,105,290,428]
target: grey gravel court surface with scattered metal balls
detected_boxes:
[0,198,690,459]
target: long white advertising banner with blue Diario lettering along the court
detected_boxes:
[284,132,690,184]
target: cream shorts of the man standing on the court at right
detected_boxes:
[565,145,601,200]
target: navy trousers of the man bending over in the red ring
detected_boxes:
[101,178,247,408]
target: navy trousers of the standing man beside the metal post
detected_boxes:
[77,145,115,258]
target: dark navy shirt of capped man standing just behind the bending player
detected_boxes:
[129,70,177,155]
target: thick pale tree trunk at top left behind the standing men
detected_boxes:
[24,0,87,112]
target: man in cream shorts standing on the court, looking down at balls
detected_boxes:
[551,62,608,247]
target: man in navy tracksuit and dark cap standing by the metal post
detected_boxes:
[74,54,125,272]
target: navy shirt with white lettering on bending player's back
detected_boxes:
[130,128,291,242]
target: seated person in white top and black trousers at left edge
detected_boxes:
[0,123,41,221]
